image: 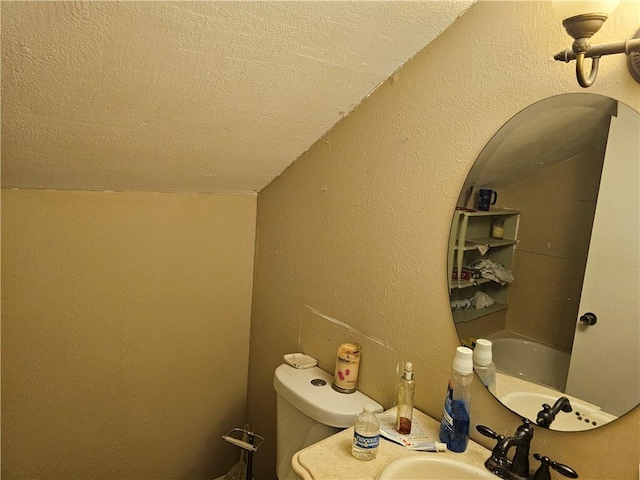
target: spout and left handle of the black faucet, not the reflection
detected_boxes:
[476,418,533,480]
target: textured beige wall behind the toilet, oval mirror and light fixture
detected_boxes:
[248,1,640,479]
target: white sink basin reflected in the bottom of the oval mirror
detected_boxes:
[500,392,616,432]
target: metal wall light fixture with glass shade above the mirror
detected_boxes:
[553,0,640,88]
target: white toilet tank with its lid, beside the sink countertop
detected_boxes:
[273,364,383,480]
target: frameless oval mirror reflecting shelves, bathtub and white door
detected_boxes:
[448,93,640,431]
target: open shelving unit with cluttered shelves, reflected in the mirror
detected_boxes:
[447,208,520,323]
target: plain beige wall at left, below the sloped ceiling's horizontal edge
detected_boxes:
[2,190,256,479]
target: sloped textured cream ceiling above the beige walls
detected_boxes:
[1,0,475,192]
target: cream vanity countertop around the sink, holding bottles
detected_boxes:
[291,410,490,480]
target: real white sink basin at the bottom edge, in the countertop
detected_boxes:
[376,453,496,480]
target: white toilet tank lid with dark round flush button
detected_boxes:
[273,364,383,428]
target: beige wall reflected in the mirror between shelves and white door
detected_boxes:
[500,149,604,352]
